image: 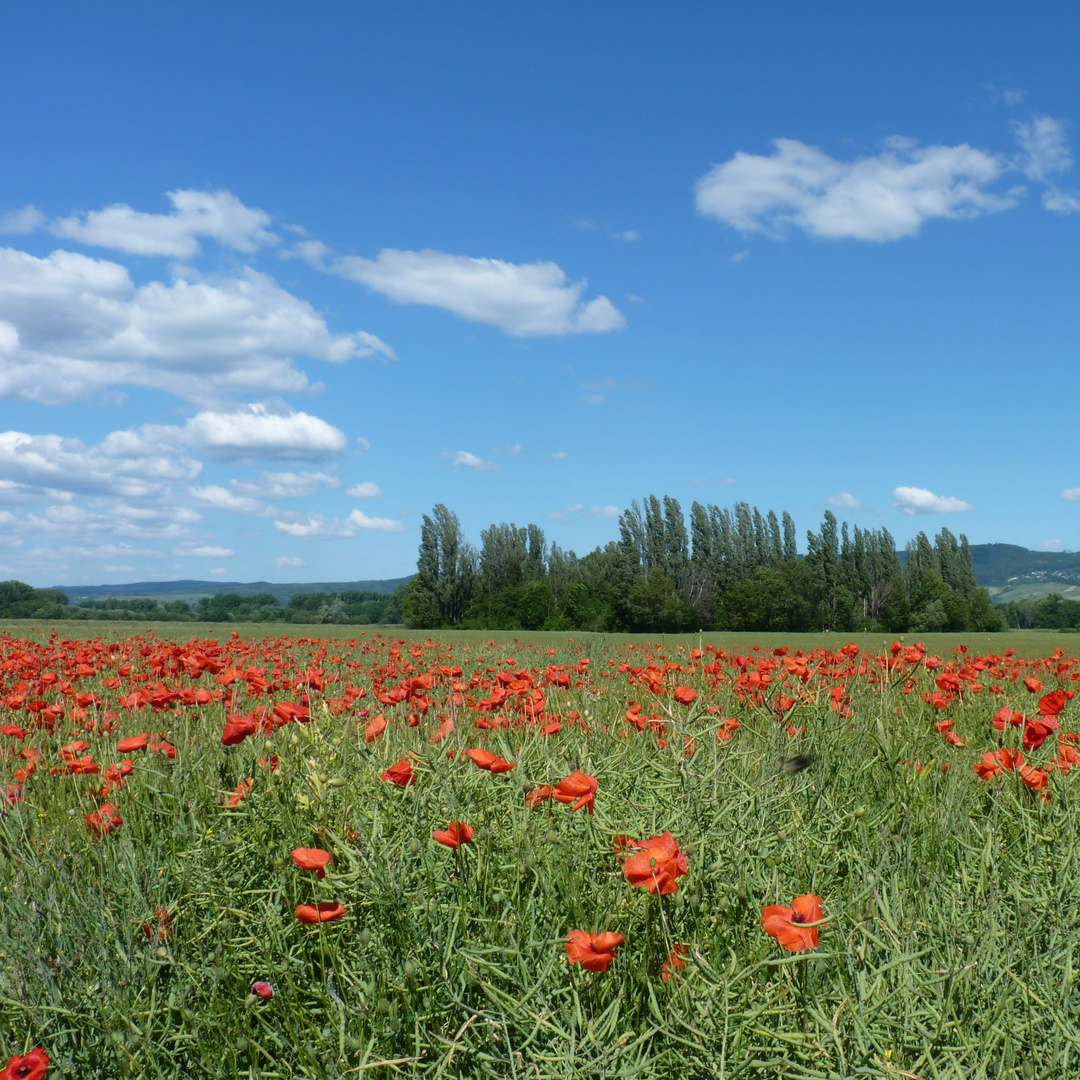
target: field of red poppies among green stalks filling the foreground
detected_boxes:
[0,631,1080,1080]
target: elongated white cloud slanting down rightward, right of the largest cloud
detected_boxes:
[315,248,626,337]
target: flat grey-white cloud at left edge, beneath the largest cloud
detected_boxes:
[0,431,202,499]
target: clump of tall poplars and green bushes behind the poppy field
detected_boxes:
[403,495,1001,633]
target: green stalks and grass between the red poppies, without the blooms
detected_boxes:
[0,624,1080,1080]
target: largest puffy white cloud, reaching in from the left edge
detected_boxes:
[0,247,393,405]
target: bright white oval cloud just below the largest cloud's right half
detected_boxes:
[156,404,348,460]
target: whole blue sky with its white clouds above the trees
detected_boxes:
[0,2,1080,585]
